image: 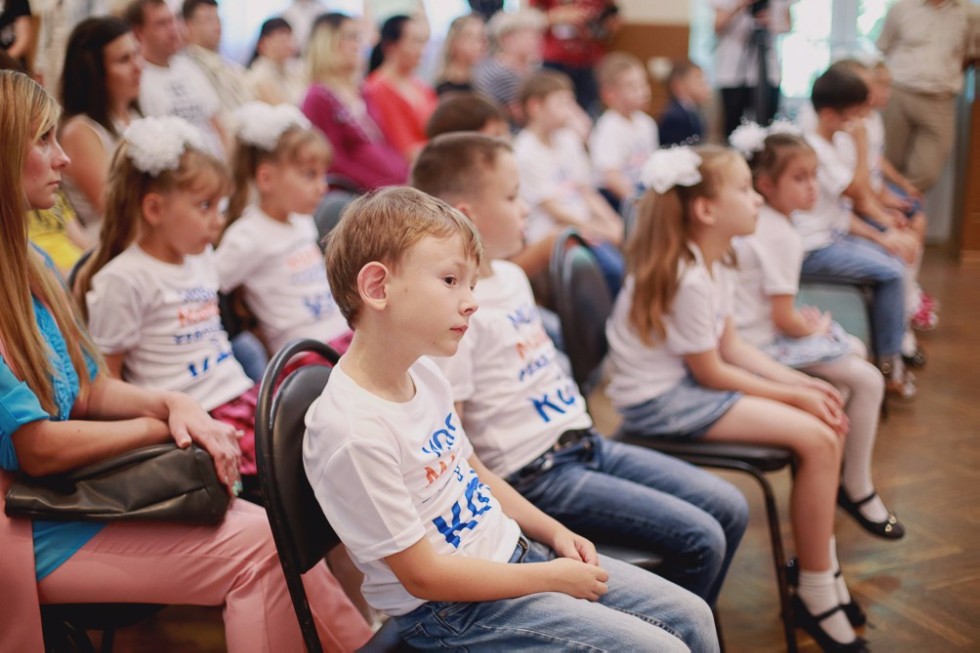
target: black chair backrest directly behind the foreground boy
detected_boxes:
[255,340,340,652]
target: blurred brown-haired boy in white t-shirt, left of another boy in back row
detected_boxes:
[514,70,625,295]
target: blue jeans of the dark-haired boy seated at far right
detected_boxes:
[803,236,905,358]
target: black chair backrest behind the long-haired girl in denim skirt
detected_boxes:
[549,229,613,393]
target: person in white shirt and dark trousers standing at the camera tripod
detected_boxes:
[711,0,793,136]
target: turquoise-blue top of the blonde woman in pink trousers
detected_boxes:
[0,298,105,581]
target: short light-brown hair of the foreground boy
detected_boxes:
[325,187,483,328]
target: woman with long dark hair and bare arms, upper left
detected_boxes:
[60,16,142,240]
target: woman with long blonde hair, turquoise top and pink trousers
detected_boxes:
[0,71,370,651]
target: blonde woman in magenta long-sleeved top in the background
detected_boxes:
[301,13,408,190]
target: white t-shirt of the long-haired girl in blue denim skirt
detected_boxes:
[606,243,735,408]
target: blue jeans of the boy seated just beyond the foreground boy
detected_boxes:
[508,434,749,605]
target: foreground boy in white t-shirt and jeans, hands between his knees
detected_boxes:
[303,188,717,651]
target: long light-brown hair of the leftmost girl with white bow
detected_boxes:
[72,141,230,318]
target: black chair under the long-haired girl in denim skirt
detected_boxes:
[550,229,796,651]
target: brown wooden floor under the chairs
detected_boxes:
[107,250,980,653]
